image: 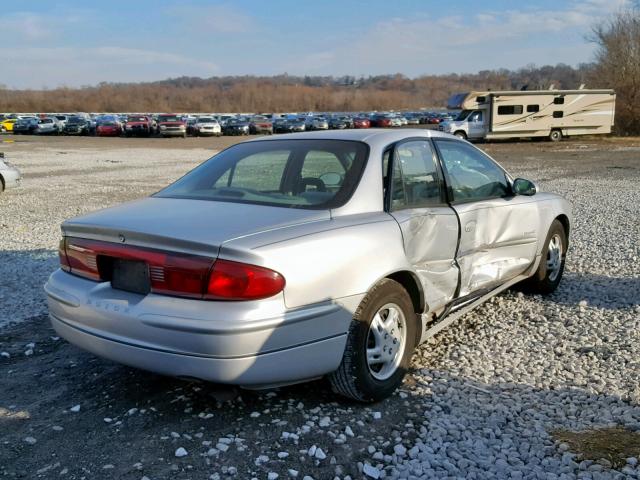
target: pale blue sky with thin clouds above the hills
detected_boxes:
[0,0,630,88]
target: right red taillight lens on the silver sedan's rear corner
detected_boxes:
[205,260,285,300]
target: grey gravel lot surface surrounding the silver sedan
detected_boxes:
[0,133,640,480]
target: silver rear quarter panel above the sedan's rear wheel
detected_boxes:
[220,213,412,308]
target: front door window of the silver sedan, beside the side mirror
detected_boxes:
[435,140,510,202]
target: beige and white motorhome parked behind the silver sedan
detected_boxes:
[439,89,616,142]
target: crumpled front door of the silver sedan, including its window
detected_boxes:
[434,139,540,297]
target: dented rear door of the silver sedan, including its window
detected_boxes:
[385,138,458,310]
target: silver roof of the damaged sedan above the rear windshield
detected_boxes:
[249,128,452,144]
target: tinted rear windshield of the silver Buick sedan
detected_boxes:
[155,139,369,209]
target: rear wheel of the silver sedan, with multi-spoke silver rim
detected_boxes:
[329,279,419,402]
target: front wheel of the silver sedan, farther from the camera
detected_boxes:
[521,219,569,295]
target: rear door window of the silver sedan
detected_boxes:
[390,140,442,210]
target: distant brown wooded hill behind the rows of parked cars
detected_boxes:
[0,64,596,112]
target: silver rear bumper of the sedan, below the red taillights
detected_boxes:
[45,270,352,388]
